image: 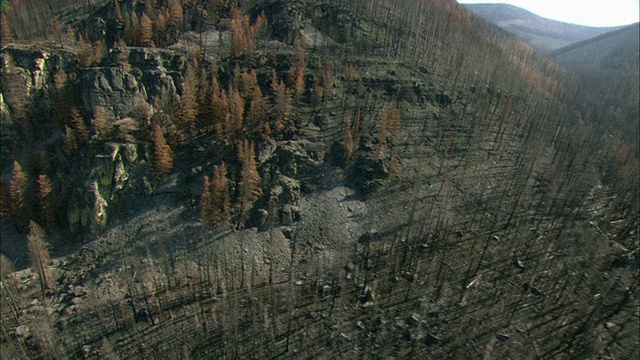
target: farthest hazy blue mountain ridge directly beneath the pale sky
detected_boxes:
[464,4,616,52]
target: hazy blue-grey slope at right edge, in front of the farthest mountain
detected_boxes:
[550,23,640,72]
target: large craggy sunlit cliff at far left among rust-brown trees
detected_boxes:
[0,45,186,236]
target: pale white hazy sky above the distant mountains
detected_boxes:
[458,0,640,26]
